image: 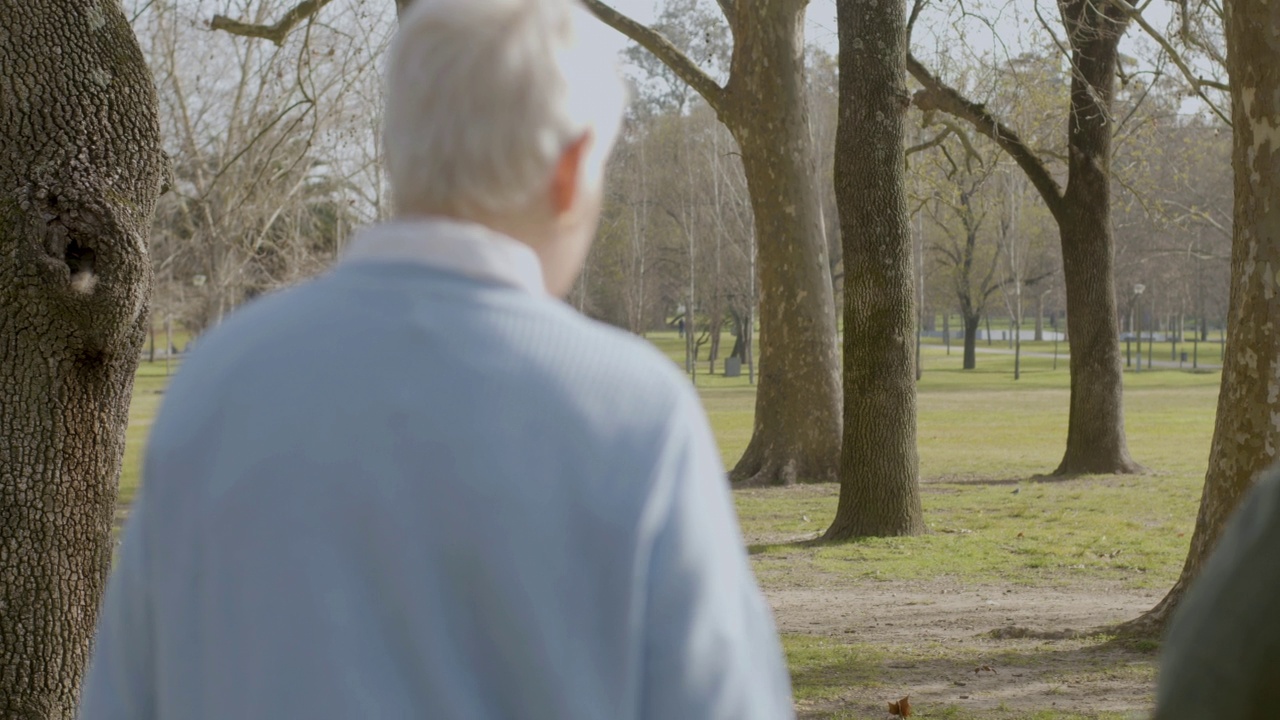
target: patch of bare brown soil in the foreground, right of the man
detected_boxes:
[765,580,1160,719]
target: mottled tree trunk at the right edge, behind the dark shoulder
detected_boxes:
[1123,0,1280,634]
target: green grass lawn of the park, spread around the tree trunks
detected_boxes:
[112,333,1220,720]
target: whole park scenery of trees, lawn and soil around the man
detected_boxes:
[0,0,1280,719]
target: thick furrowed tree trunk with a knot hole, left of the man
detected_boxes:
[0,0,165,720]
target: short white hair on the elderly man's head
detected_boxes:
[384,0,626,219]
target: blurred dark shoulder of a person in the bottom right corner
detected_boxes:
[1156,466,1280,720]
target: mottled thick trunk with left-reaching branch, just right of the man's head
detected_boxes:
[585,0,841,484]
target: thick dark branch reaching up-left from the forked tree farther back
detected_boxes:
[906,54,1064,217]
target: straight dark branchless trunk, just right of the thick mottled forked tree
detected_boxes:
[824,0,924,541]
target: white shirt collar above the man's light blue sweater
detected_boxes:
[343,218,547,295]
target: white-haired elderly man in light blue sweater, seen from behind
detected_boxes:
[81,0,792,720]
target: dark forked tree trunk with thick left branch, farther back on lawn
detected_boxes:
[908,0,1142,475]
